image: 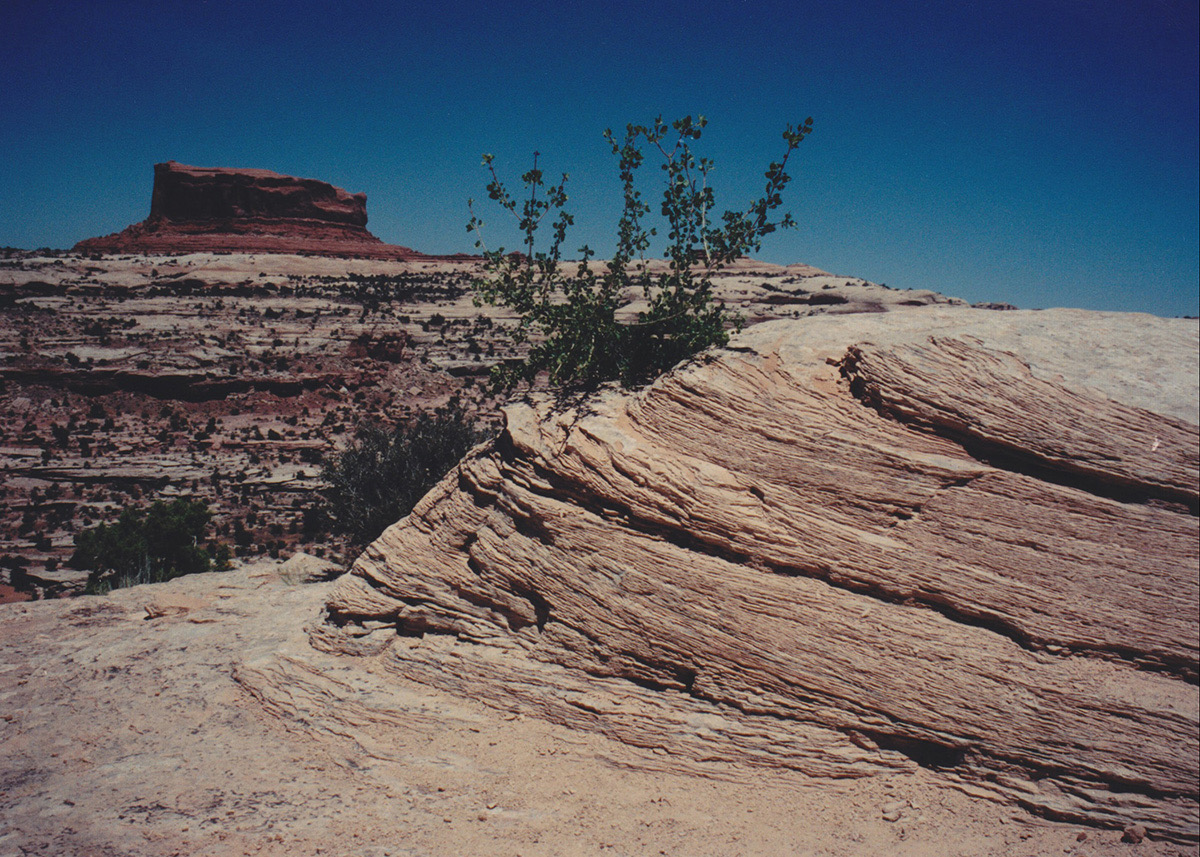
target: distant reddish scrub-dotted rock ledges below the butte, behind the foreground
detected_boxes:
[0,244,961,598]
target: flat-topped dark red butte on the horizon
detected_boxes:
[76,161,432,259]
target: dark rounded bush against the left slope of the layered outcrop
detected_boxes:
[320,401,486,546]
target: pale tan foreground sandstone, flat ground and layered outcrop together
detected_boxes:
[0,295,1200,857]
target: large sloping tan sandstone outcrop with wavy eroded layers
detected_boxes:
[313,307,1200,840]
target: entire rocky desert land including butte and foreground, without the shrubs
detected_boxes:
[0,154,1200,857]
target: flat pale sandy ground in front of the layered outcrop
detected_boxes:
[0,562,1198,857]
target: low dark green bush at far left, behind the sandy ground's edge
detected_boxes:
[70,498,229,594]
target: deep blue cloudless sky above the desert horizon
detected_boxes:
[0,0,1200,314]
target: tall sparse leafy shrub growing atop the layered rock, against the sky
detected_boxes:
[467,116,812,390]
